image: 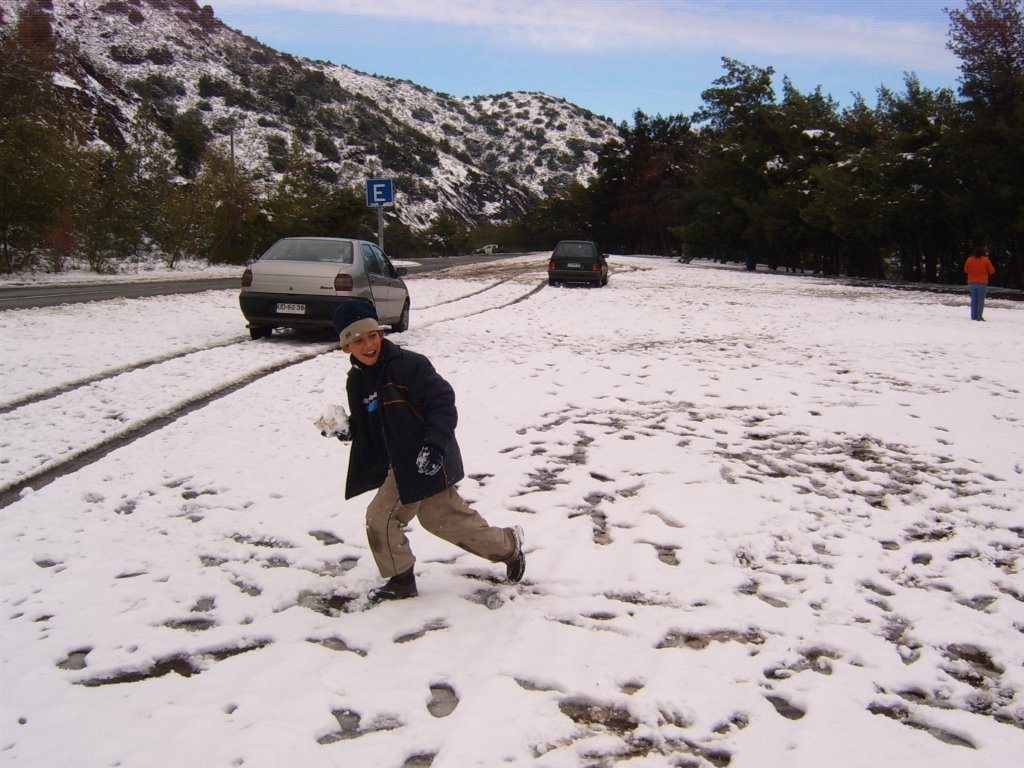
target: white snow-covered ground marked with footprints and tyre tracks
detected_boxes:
[0,257,1024,768]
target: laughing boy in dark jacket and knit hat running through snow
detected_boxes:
[334,301,526,602]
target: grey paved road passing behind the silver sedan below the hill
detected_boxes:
[0,254,512,310]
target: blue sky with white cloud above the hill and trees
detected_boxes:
[211,0,964,123]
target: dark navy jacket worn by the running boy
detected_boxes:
[345,339,464,504]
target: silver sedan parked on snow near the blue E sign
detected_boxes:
[239,238,410,339]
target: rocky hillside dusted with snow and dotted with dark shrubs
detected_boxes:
[0,0,617,228]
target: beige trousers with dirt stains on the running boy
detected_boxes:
[367,471,516,579]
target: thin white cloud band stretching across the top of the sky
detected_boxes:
[217,0,955,71]
